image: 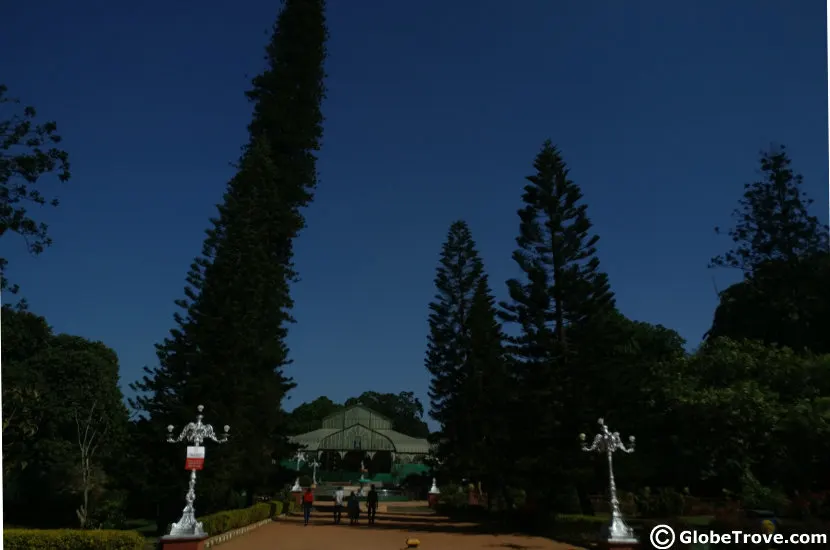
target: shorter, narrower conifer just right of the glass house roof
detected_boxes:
[425,221,509,479]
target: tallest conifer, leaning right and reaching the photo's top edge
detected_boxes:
[128,0,327,519]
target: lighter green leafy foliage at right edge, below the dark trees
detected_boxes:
[658,338,830,493]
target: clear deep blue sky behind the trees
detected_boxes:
[0,0,828,430]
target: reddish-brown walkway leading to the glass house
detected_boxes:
[221,511,577,550]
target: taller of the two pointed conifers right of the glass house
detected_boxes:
[501,141,614,504]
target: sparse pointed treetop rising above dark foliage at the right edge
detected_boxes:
[710,146,828,275]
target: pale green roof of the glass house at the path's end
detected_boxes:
[289,405,430,455]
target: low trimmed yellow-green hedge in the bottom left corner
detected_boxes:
[3,529,145,550]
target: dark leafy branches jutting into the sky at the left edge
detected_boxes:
[0,84,70,298]
